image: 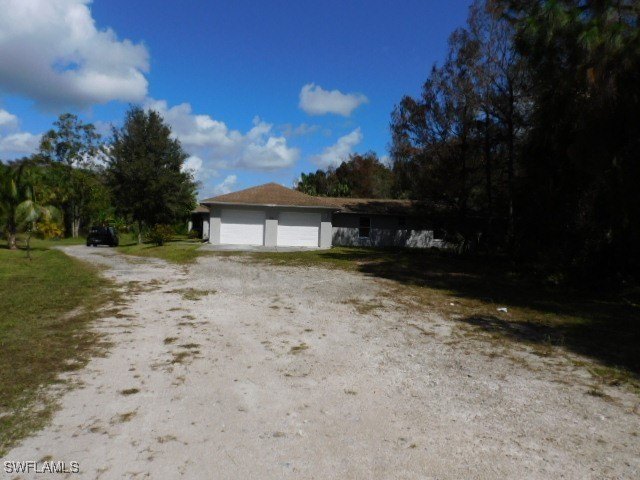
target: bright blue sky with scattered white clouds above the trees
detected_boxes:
[0,0,470,196]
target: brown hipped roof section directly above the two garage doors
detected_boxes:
[200,183,335,209]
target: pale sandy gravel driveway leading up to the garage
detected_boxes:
[6,246,640,480]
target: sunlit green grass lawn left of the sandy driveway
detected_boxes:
[0,239,110,456]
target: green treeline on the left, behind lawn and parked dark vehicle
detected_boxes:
[0,107,196,248]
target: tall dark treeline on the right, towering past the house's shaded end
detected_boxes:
[299,0,640,280]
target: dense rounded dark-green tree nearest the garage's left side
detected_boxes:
[107,107,196,242]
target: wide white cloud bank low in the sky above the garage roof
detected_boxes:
[145,99,300,170]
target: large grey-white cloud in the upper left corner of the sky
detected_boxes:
[0,0,149,109]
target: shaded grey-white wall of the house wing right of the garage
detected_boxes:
[333,213,446,248]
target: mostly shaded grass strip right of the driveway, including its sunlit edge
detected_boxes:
[217,247,640,392]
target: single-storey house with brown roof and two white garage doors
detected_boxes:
[192,183,444,248]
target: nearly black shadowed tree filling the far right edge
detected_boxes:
[508,0,640,279]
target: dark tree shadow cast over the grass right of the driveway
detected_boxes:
[321,249,640,379]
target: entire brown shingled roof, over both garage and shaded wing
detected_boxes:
[200,183,438,215]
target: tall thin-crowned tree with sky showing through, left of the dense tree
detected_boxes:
[39,113,102,238]
